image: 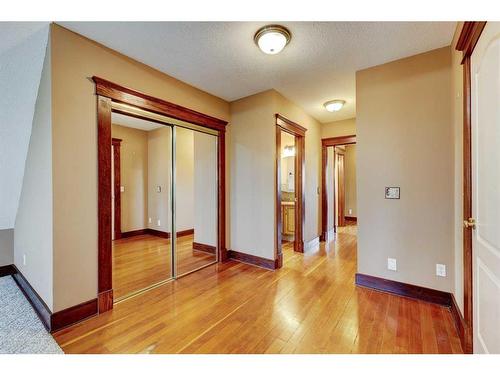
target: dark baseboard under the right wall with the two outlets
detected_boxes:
[356,273,452,307]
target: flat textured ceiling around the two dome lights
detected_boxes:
[60,22,455,122]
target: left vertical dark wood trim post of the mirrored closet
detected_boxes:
[97,96,113,312]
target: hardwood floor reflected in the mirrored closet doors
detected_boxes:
[113,234,215,299]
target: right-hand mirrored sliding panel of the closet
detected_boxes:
[175,127,217,276]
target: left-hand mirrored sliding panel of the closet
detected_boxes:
[111,112,173,300]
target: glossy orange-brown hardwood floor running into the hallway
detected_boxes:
[54,225,462,353]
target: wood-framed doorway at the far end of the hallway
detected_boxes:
[320,135,357,241]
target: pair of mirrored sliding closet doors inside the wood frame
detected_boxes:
[111,104,218,302]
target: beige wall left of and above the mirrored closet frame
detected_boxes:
[50,25,229,311]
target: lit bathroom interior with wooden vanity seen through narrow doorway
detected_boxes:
[281,131,296,244]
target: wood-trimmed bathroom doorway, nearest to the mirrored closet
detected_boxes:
[275,114,307,268]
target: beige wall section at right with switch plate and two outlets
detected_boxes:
[356,47,455,291]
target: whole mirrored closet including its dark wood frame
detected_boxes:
[93,77,227,313]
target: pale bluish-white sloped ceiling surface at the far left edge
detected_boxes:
[0,22,49,229]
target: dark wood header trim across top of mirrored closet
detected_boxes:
[92,76,227,131]
